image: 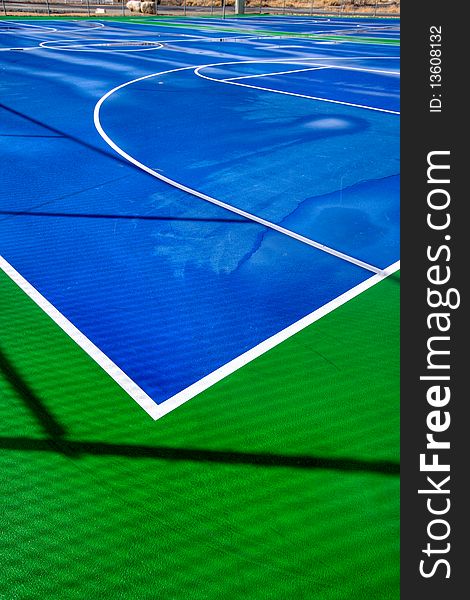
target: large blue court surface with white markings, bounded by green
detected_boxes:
[0,17,399,416]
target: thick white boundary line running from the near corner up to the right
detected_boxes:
[154,261,400,420]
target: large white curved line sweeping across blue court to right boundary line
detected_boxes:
[93,66,382,274]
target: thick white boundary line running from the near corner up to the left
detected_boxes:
[0,255,158,419]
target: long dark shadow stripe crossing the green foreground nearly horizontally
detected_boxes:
[0,436,400,475]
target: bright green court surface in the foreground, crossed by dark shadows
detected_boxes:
[0,273,399,600]
